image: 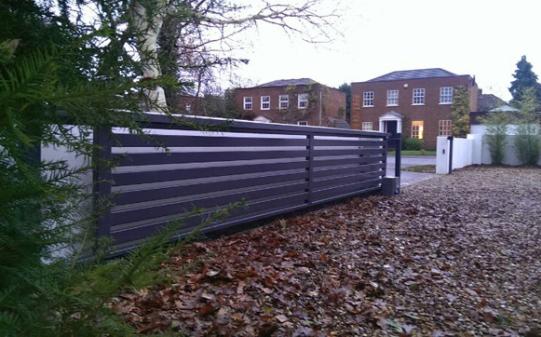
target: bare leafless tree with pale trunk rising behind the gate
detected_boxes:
[131,0,337,109]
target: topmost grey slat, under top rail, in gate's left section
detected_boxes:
[113,134,308,147]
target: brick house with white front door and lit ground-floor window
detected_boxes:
[351,68,479,149]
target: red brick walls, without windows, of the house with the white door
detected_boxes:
[351,75,479,149]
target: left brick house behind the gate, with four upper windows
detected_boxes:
[234,78,347,127]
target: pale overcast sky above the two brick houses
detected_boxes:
[231,0,541,100]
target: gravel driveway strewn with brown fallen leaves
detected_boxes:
[113,167,541,336]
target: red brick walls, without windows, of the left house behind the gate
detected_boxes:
[234,83,346,126]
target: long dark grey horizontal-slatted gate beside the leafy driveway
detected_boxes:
[95,115,387,252]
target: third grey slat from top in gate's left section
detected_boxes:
[113,161,308,186]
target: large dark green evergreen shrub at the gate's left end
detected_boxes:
[0,0,185,337]
